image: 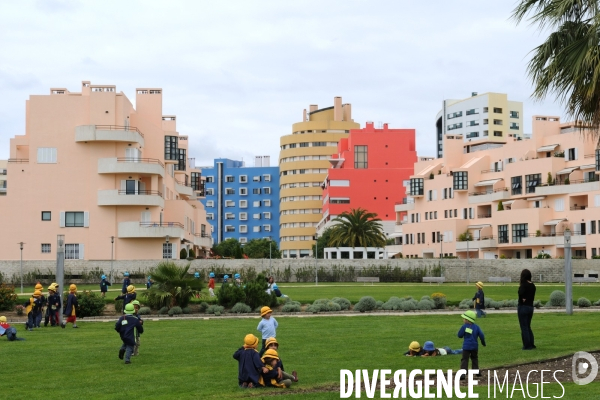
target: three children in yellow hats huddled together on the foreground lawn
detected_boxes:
[233,306,298,388]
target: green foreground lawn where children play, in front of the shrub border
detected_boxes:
[0,313,600,399]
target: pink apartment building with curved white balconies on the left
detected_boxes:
[0,81,212,260]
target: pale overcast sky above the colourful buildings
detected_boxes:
[0,0,563,165]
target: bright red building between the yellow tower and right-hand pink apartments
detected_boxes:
[318,122,417,233]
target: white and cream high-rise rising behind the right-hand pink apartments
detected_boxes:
[435,92,523,158]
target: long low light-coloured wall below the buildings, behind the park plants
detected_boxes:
[0,259,600,283]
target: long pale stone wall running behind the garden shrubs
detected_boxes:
[0,259,600,283]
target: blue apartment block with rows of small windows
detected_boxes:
[201,156,279,245]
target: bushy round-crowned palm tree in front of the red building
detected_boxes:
[328,208,386,247]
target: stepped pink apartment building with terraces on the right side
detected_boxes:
[395,116,600,259]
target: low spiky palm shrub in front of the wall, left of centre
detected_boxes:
[144,261,204,308]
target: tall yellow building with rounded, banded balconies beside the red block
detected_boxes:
[279,97,360,258]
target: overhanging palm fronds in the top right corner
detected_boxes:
[513,0,600,138]
